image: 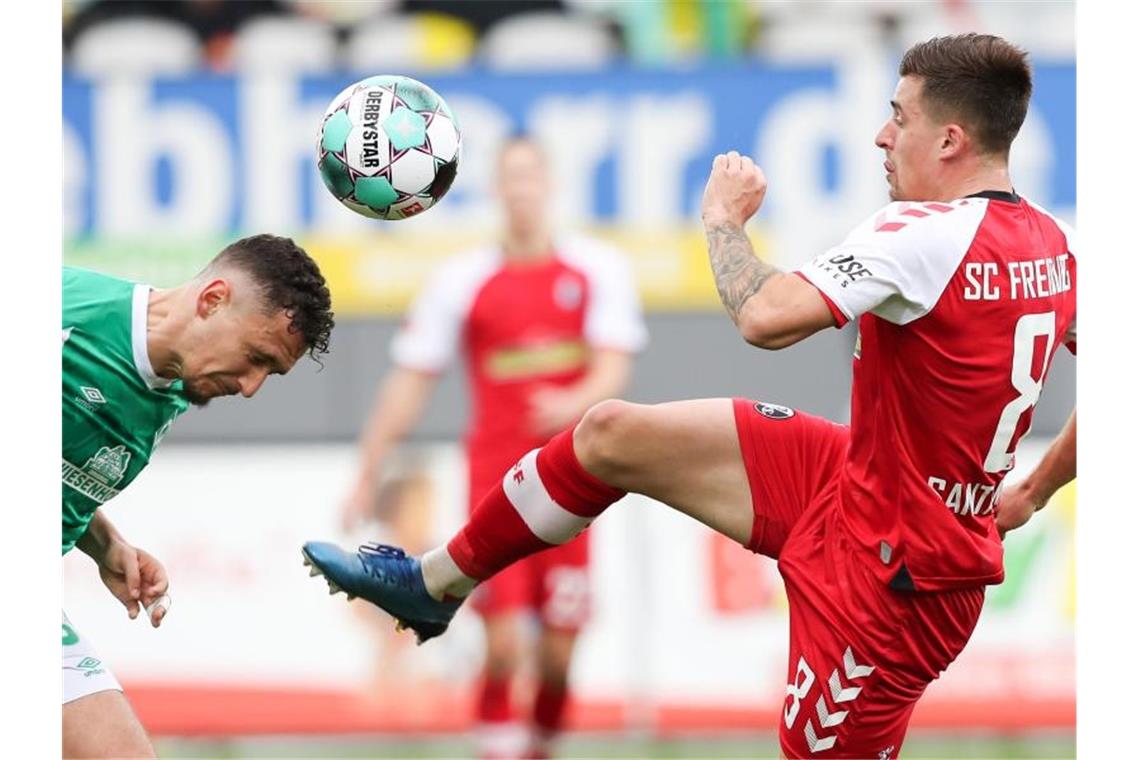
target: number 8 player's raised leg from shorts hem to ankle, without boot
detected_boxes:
[423,399,752,598]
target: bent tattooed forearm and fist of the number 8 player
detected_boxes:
[701,150,836,349]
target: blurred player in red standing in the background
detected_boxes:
[343,138,646,757]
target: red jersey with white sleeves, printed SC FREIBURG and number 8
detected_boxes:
[798,193,1076,590]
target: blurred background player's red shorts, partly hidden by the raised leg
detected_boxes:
[470,451,591,632]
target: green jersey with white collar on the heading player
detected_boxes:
[63,267,189,554]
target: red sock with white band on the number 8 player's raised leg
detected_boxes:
[447,428,626,580]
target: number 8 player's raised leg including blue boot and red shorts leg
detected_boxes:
[303,399,848,641]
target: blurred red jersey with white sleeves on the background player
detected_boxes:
[392,237,648,458]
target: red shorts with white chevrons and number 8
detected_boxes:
[733,399,984,759]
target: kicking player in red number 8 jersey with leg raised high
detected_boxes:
[306,34,1076,759]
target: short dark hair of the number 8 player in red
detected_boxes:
[898,32,1033,155]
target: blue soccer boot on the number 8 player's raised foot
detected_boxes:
[301,541,463,644]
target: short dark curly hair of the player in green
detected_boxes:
[210,235,335,359]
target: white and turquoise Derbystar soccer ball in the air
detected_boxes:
[317,76,461,219]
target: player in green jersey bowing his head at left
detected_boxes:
[63,235,333,757]
